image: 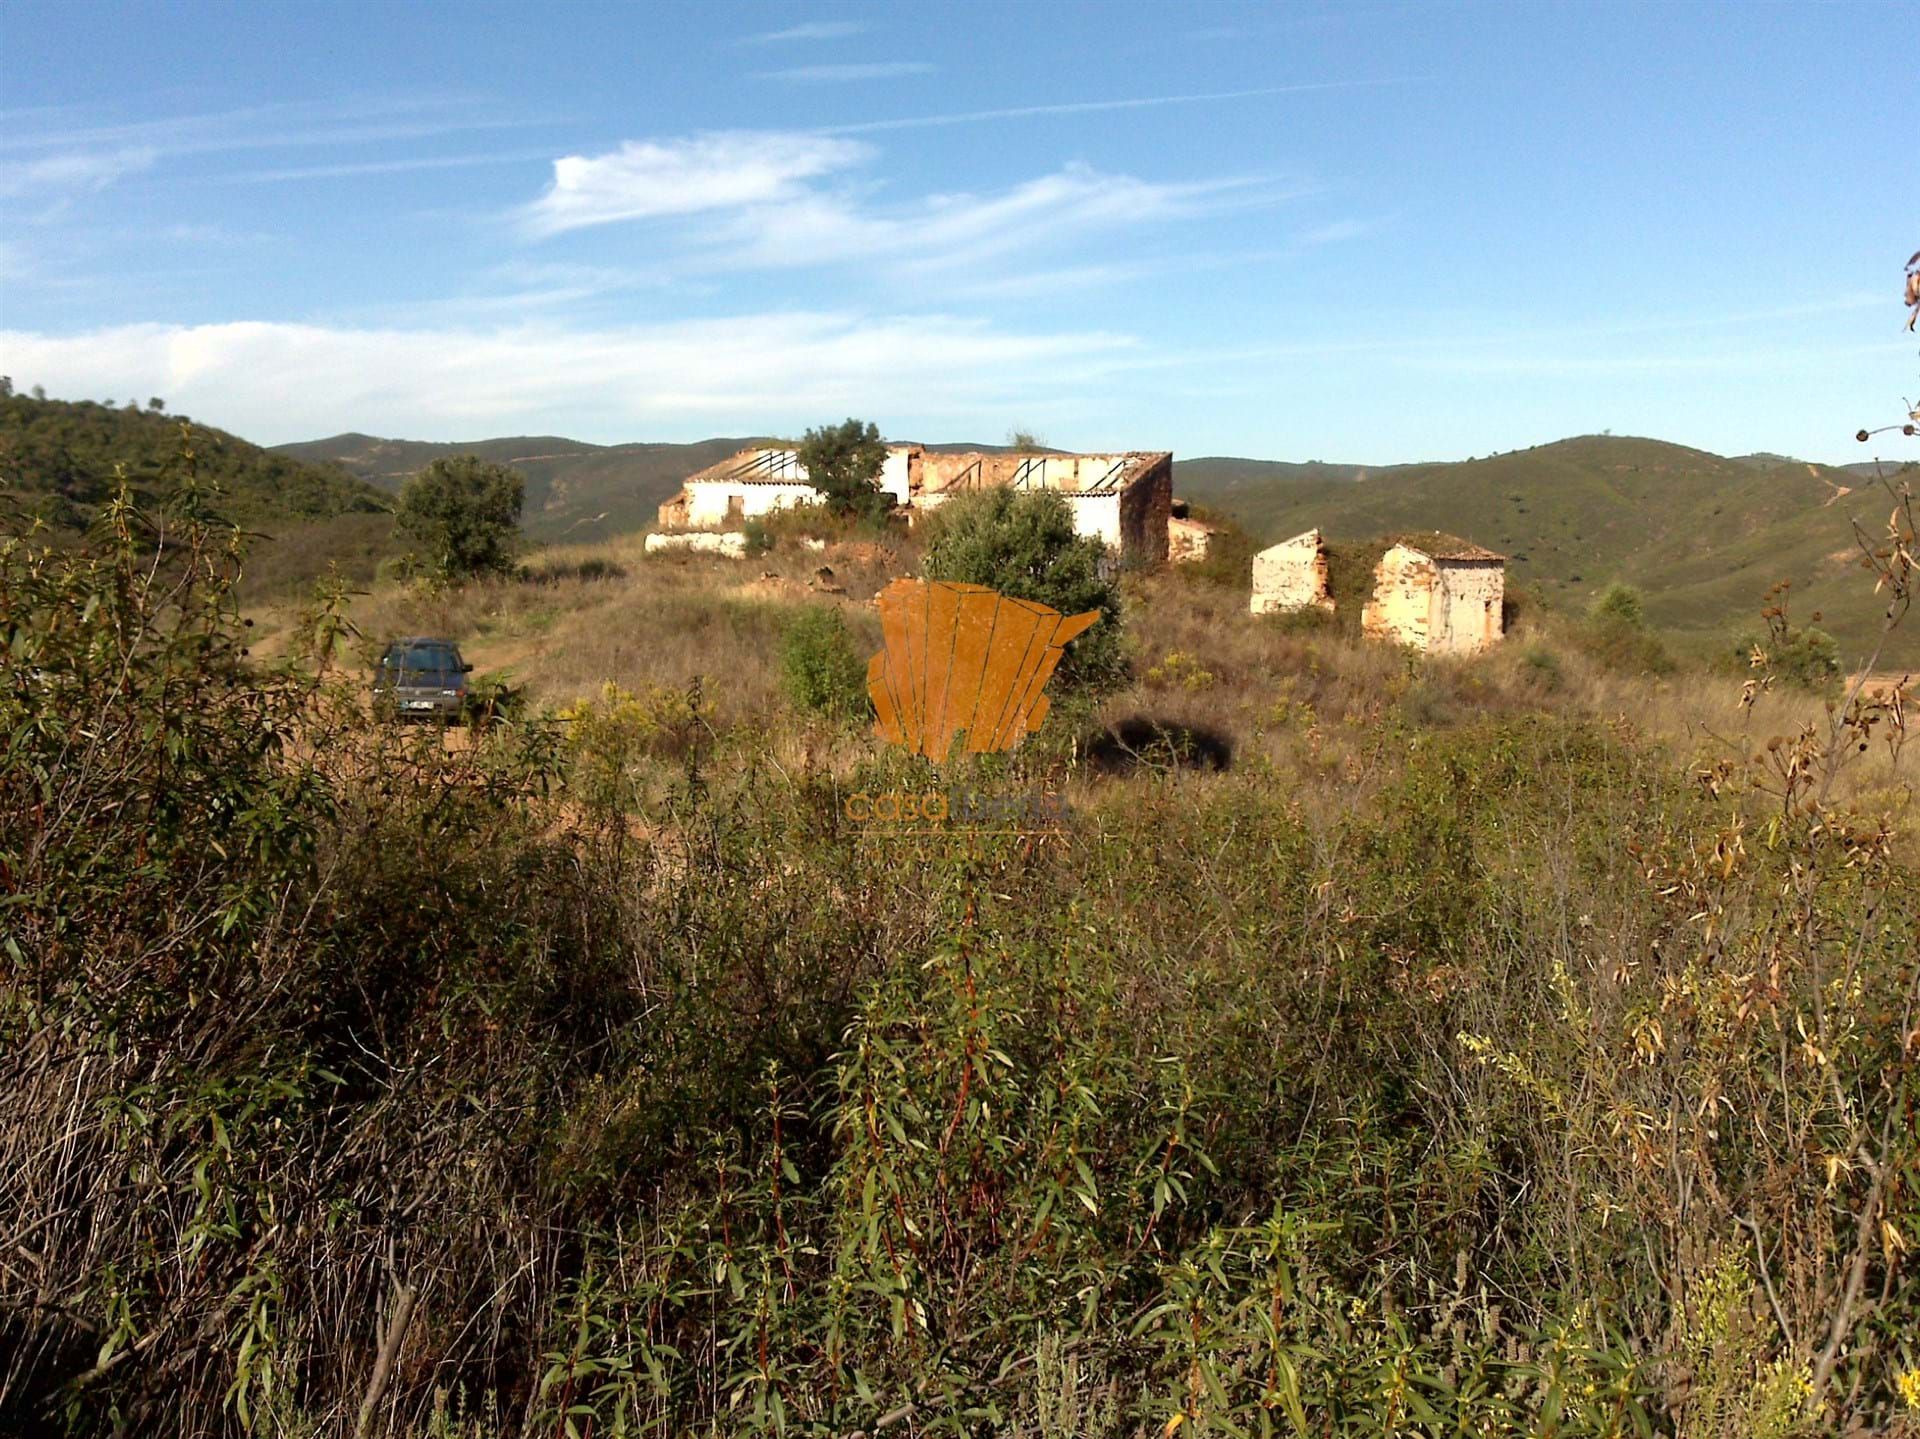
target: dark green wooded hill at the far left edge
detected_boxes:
[0,394,390,528]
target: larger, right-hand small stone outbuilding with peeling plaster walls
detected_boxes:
[1359,534,1507,655]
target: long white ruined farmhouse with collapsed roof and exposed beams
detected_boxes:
[659,444,1173,565]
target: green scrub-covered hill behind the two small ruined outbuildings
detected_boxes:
[1175,434,1920,663]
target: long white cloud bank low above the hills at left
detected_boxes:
[0,313,1142,444]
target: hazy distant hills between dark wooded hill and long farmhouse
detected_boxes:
[275,434,753,540]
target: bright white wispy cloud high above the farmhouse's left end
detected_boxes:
[522,131,870,234]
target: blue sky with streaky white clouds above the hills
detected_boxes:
[0,0,1920,463]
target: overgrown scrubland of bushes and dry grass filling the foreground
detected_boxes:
[0,487,1920,1439]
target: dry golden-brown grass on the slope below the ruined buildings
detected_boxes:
[253,534,1910,837]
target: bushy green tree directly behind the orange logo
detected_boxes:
[922,488,1127,684]
